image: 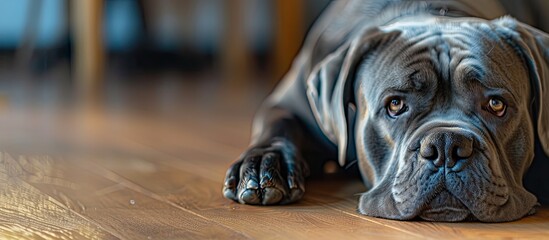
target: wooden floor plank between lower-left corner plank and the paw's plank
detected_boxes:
[0,153,248,239]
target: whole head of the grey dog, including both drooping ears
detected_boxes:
[308,18,549,222]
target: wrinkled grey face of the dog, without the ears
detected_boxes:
[355,18,536,221]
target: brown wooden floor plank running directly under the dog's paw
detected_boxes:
[88,145,418,239]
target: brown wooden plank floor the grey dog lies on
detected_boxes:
[0,72,549,239]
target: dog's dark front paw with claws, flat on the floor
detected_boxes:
[223,138,309,205]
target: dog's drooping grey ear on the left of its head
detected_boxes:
[307,28,399,166]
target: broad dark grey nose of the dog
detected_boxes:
[419,130,473,168]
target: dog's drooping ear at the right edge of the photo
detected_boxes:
[497,17,549,157]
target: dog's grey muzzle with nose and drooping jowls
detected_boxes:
[393,124,508,221]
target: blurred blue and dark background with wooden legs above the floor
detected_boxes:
[0,0,329,91]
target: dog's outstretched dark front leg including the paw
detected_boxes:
[223,107,330,205]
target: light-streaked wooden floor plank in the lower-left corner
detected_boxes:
[0,153,117,239]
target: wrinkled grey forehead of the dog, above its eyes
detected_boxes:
[367,24,517,113]
